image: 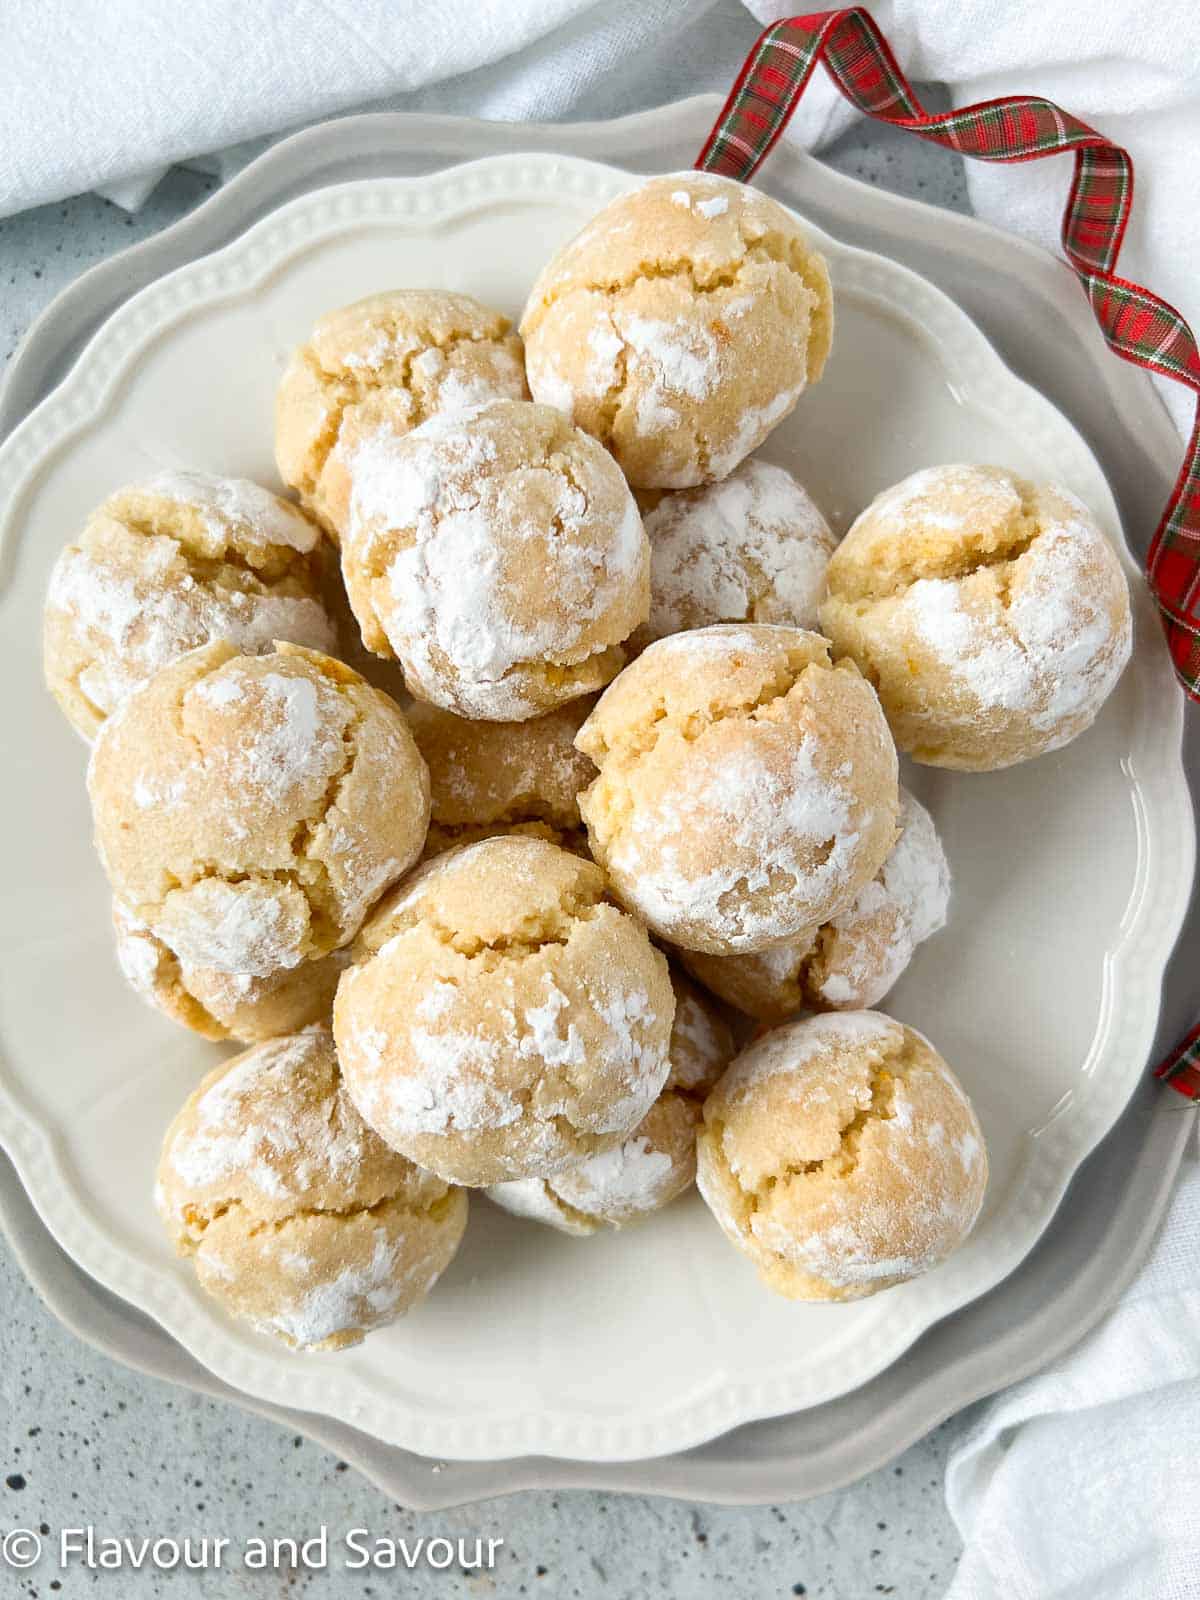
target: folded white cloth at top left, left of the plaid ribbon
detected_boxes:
[0,0,755,216]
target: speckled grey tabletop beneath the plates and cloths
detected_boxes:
[0,85,966,1600]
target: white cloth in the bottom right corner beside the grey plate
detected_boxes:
[946,1132,1200,1600]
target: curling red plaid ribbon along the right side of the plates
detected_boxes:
[696,6,1200,1099]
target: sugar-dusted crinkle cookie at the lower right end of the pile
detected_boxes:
[696,1011,987,1301]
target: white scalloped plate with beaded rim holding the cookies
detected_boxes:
[0,155,1194,1461]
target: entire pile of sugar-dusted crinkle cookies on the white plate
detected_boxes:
[45,173,1131,1349]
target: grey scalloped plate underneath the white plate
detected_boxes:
[0,99,1187,1506]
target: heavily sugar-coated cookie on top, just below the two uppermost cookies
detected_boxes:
[342,400,650,722]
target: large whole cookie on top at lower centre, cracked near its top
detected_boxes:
[333,837,675,1187]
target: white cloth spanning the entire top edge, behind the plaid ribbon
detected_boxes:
[0,0,1200,430]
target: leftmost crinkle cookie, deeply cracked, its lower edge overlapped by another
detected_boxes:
[42,472,336,739]
